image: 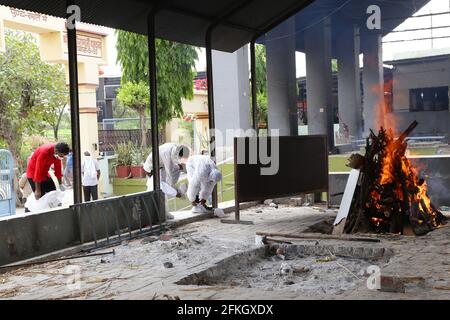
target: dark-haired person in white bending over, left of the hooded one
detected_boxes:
[144,143,189,219]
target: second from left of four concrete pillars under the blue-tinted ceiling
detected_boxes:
[305,18,334,148]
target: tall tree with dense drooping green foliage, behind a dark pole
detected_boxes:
[116,30,198,128]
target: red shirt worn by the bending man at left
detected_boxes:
[27,143,62,182]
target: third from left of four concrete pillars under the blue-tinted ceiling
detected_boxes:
[336,24,362,139]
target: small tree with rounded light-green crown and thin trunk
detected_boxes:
[117,81,150,148]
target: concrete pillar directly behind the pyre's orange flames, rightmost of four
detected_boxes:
[361,34,384,136]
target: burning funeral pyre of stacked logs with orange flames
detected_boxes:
[344,122,446,235]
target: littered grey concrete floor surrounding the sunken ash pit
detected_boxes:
[0,205,450,299]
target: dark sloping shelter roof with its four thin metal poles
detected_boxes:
[0,0,314,208]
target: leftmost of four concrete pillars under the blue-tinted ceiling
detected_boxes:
[266,18,298,136]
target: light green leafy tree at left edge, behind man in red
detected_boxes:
[0,30,67,166]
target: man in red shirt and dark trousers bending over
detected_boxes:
[27,142,70,200]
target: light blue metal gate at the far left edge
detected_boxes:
[0,149,16,217]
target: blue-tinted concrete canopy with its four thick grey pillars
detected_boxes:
[257,0,429,141]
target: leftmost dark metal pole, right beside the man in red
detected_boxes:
[66,0,82,204]
